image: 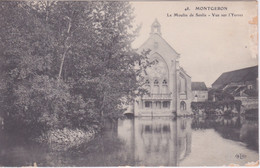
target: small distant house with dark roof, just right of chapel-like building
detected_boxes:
[191,82,208,102]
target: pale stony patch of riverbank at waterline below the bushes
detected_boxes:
[35,128,100,151]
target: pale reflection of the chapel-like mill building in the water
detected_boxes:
[118,117,191,166]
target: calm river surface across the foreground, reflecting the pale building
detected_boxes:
[0,117,258,166]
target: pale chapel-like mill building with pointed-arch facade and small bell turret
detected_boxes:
[134,20,192,116]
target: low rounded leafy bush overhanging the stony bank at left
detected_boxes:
[4,76,99,134]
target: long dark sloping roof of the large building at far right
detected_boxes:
[212,66,258,87]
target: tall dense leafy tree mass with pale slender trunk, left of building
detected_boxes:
[0,1,146,133]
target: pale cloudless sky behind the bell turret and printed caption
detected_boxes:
[131,1,258,87]
